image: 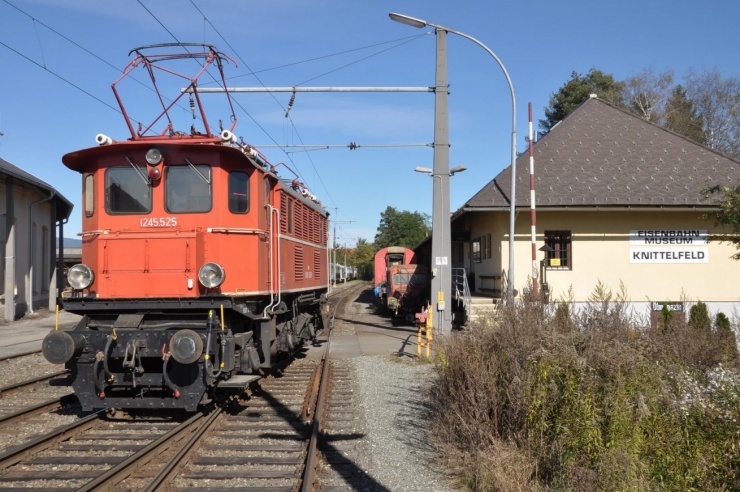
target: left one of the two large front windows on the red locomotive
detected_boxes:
[105,166,152,214]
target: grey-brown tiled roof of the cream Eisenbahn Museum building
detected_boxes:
[462,97,740,210]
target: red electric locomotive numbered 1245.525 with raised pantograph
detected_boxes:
[43,43,329,411]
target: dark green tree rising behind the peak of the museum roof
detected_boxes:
[539,68,624,134]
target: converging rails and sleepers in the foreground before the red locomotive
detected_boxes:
[0,287,368,492]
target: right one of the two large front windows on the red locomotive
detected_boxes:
[164,164,213,213]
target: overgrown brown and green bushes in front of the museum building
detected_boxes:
[431,285,740,491]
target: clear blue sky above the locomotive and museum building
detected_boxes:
[0,0,740,245]
